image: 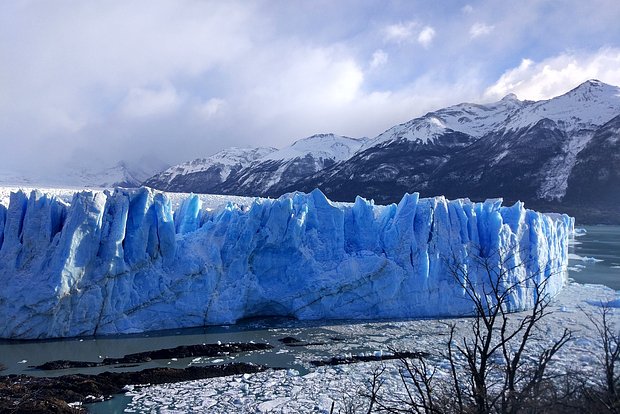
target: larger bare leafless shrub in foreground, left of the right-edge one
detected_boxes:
[358,247,572,414]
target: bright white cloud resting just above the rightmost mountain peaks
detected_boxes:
[485,48,620,100]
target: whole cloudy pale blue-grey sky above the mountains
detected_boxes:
[0,0,620,171]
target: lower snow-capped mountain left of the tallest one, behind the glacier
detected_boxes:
[144,134,365,195]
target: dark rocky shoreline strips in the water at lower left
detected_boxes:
[0,342,273,413]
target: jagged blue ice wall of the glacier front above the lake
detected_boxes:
[0,188,573,338]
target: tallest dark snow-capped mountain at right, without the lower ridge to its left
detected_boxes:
[285,81,620,222]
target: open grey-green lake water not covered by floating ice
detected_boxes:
[0,226,620,413]
